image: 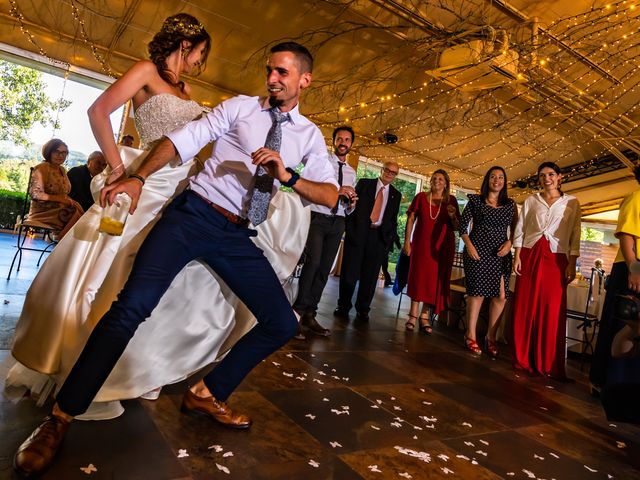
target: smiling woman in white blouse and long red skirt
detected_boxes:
[513,162,580,380]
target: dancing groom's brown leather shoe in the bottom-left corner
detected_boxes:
[13,415,71,478]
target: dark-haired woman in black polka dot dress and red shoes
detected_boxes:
[460,167,518,358]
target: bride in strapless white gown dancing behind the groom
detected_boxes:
[6,13,308,419]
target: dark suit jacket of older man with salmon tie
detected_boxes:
[346,178,402,249]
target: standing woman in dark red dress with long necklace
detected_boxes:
[403,170,460,335]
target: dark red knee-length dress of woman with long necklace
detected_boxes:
[407,192,460,314]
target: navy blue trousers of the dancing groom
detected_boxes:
[57,191,298,416]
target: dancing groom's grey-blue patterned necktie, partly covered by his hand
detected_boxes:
[247,107,291,227]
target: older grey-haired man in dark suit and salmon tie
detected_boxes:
[334,162,402,321]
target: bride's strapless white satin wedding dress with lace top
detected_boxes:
[6,94,310,419]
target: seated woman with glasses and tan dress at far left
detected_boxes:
[28,138,84,240]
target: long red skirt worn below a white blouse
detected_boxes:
[513,236,568,379]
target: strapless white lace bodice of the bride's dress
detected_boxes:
[134,93,203,150]
